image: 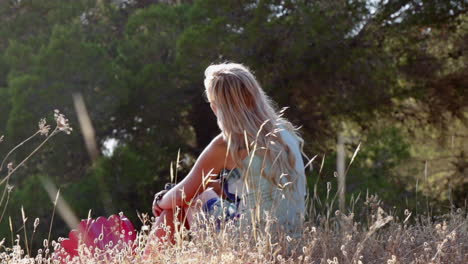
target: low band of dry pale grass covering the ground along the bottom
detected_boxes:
[0,197,468,264]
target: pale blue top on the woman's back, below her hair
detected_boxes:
[229,129,306,236]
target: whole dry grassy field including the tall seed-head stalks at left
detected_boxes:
[0,114,468,264]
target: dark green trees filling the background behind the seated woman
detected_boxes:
[0,0,468,250]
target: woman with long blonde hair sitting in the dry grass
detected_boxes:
[148,63,306,246]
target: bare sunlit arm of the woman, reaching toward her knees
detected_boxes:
[158,136,227,209]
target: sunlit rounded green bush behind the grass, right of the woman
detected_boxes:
[309,127,414,209]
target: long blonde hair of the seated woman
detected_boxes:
[204,63,304,189]
